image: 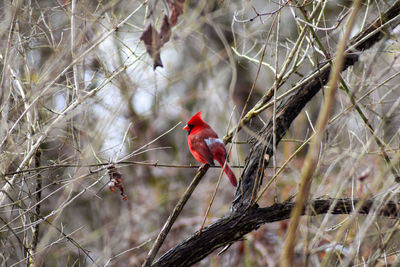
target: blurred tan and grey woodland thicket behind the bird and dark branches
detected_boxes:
[0,0,400,266]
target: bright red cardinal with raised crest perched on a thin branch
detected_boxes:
[183,111,237,187]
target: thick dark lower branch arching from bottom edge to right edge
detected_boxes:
[152,199,400,267]
